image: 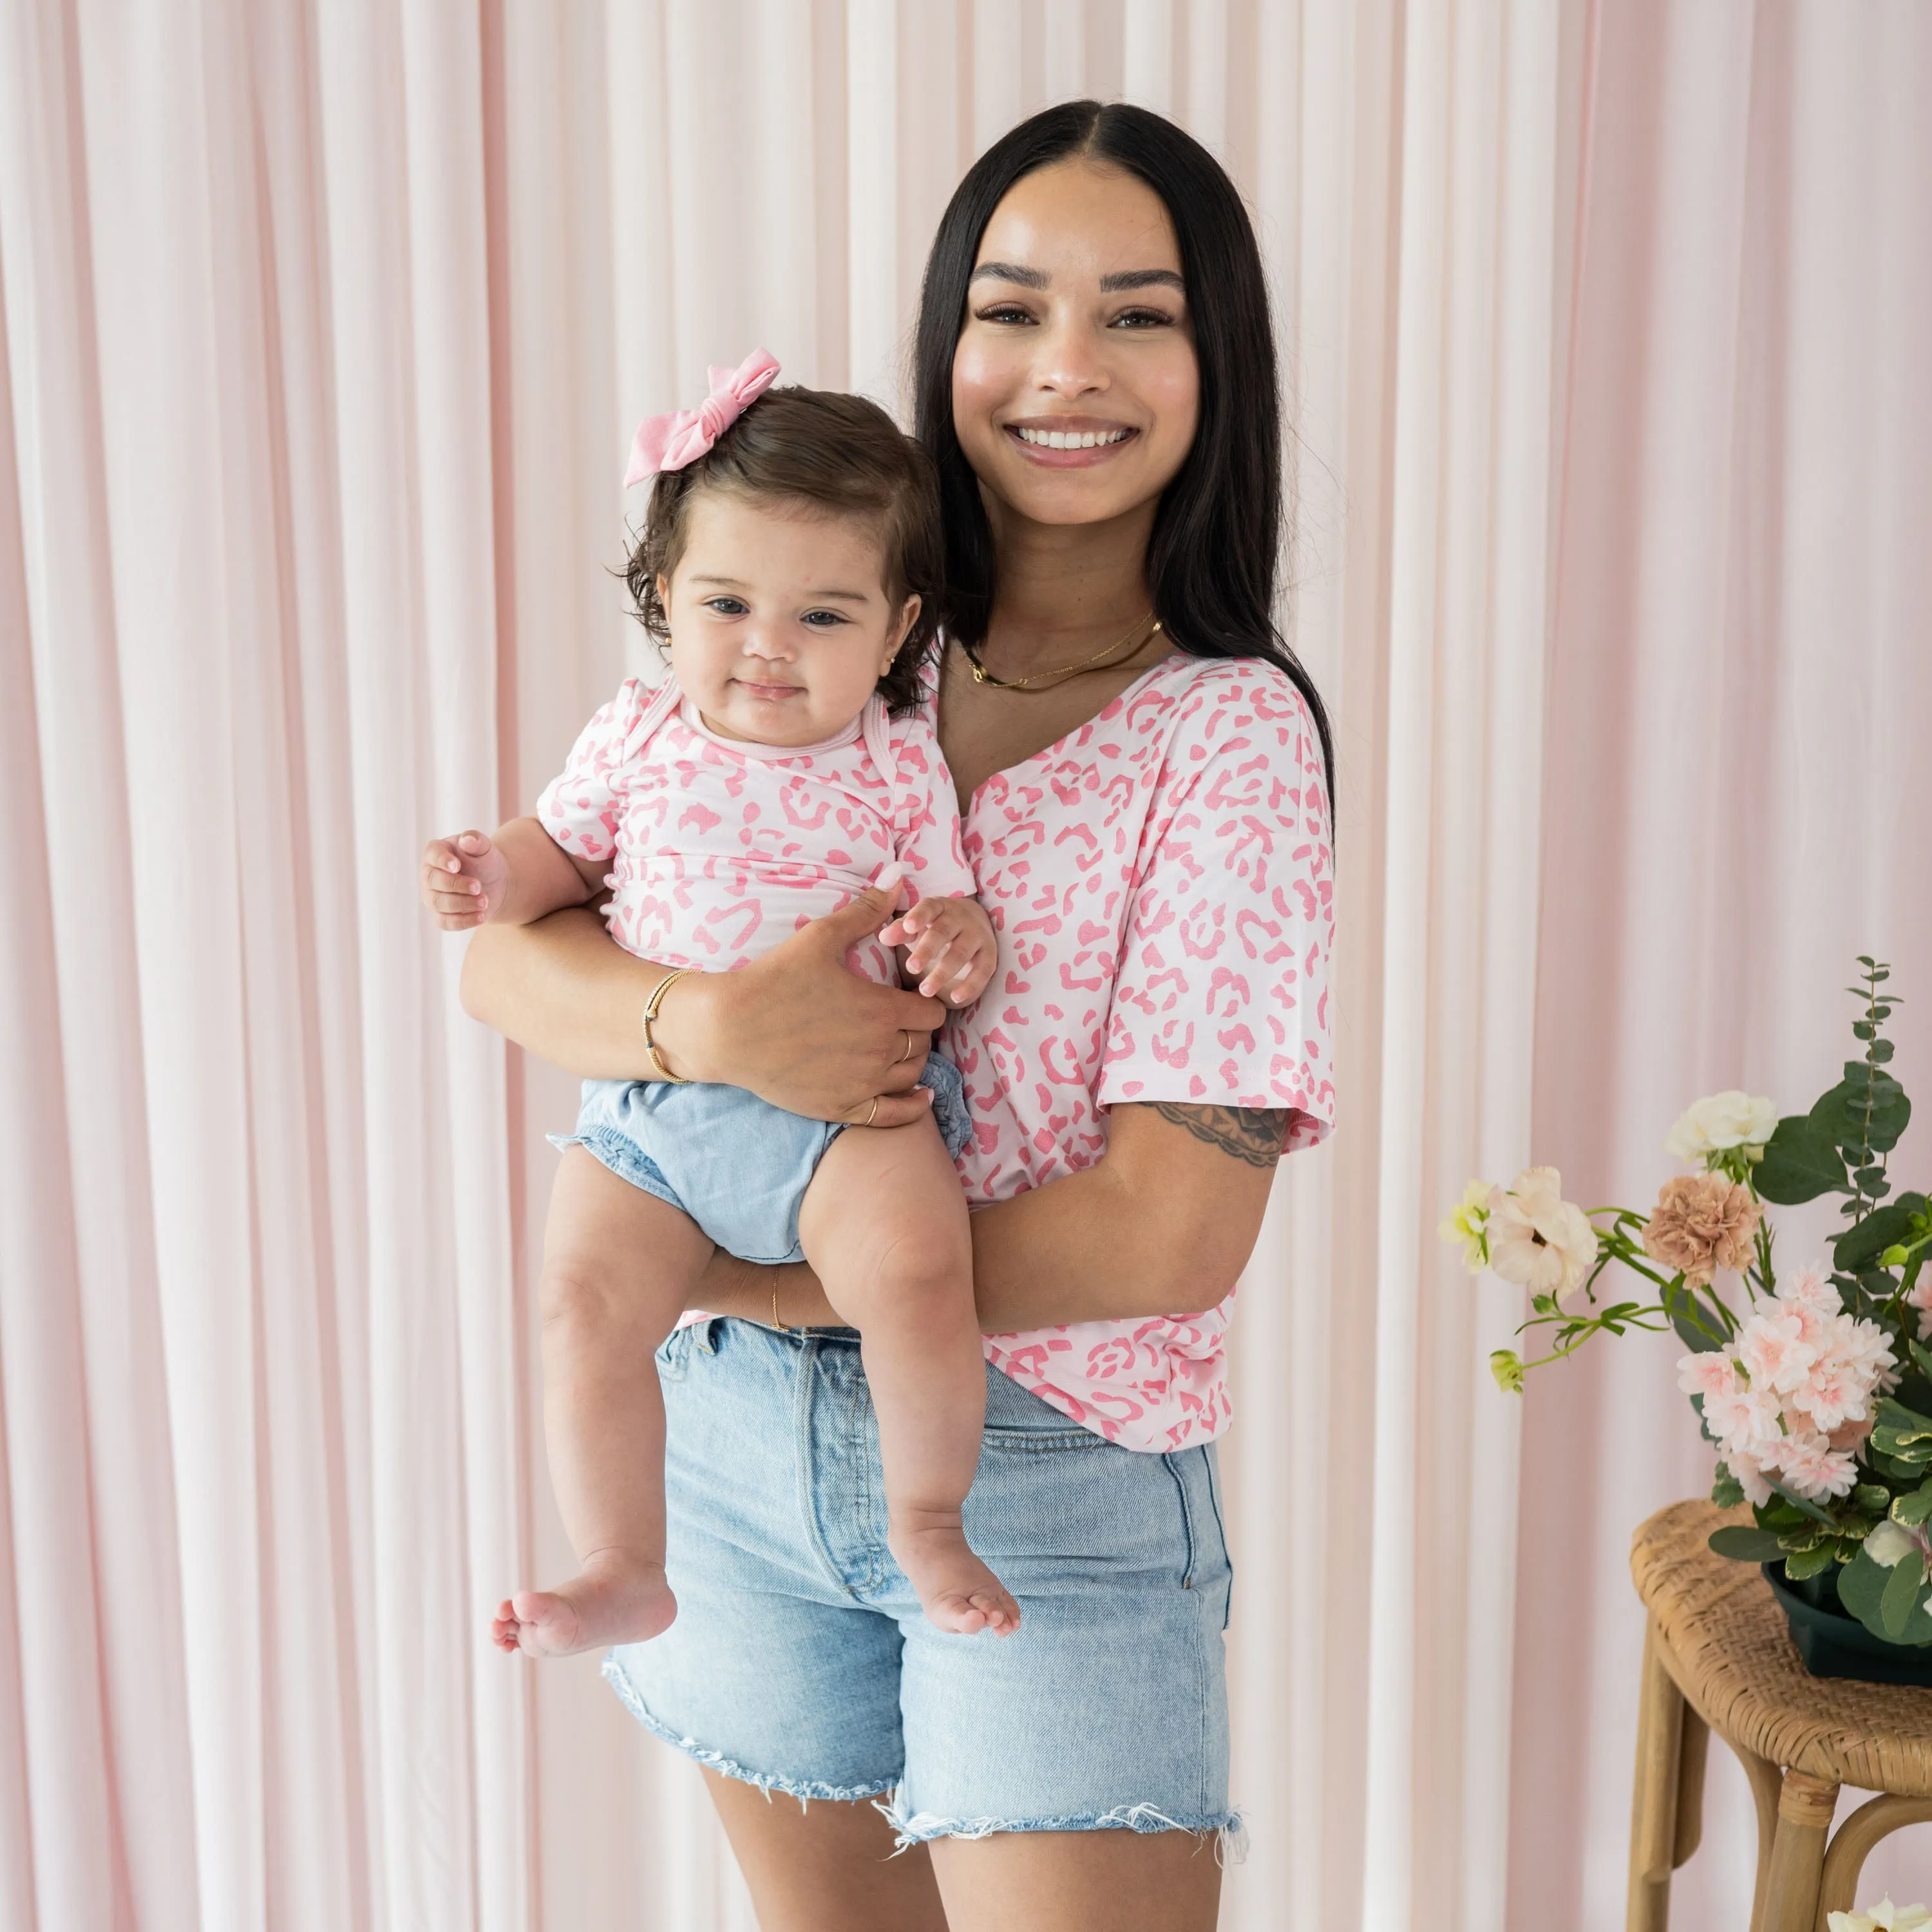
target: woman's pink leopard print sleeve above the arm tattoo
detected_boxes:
[1097,661,1335,1150]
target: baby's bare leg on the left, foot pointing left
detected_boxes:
[491,1148,711,1658]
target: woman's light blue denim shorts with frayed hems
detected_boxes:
[605,1320,1238,1845]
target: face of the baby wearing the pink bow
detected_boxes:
[659,491,920,744]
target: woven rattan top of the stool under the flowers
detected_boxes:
[1631,1501,1932,1797]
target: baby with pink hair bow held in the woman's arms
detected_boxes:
[423,354,1020,1656]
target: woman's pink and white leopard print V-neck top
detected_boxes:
[929,657,1335,1451]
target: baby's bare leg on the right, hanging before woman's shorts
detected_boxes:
[798,1117,1020,1636]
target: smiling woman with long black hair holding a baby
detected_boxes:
[464,102,1333,1932]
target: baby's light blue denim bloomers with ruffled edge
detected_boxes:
[551,1053,972,1262]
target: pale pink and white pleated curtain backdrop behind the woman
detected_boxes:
[0,0,1932,1932]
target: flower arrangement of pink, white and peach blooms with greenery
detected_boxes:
[1441,956,1932,1644]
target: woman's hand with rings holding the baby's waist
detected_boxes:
[651,883,945,1126]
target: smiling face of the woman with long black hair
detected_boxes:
[952,160,1200,524]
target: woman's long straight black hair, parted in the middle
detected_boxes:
[914,100,1335,813]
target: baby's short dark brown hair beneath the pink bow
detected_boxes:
[624,386,945,717]
